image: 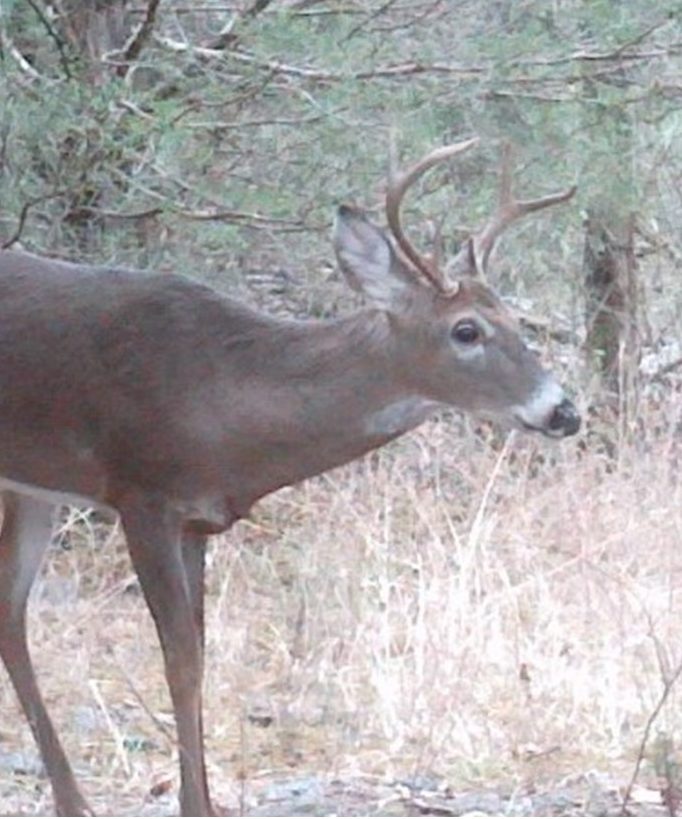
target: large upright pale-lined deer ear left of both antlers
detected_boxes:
[334,205,414,310]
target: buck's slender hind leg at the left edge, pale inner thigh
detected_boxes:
[0,493,92,816]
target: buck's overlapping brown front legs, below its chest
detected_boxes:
[118,493,212,816]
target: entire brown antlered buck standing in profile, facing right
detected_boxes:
[0,140,580,816]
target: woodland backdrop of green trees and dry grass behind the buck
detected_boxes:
[0,0,682,813]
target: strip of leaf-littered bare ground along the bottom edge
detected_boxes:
[0,758,675,816]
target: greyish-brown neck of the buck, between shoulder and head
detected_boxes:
[218,311,436,500]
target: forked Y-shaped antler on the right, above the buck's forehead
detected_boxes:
[449,143,577,277]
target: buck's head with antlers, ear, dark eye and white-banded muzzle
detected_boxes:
[334,139,580,438]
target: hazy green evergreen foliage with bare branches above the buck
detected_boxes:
[0,0,680,320]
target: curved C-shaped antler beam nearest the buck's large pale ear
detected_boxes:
[386,137,478,290]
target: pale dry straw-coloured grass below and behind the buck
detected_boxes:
[0,410,682,813]
